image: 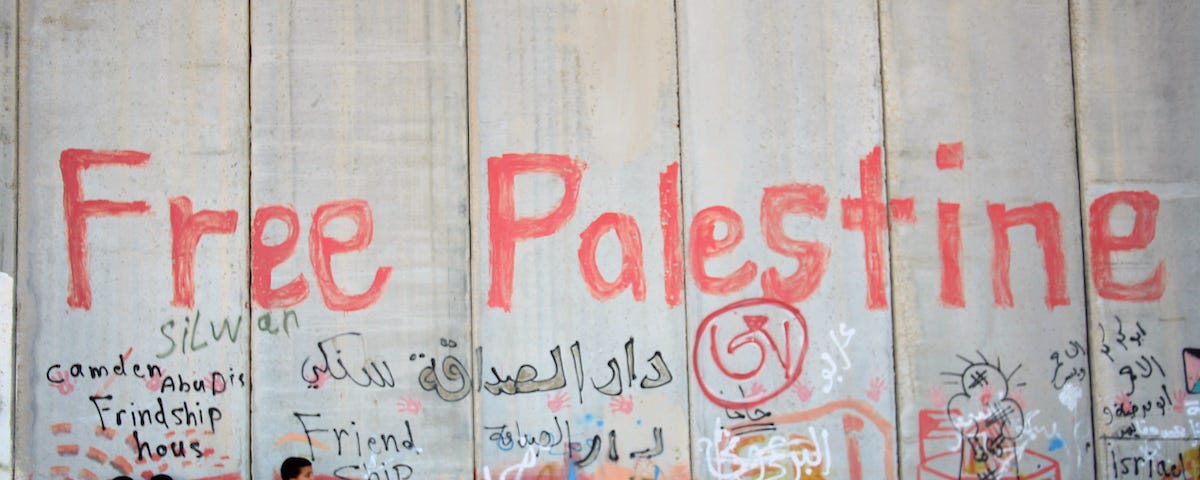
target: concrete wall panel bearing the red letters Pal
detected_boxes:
[468,1,690,479]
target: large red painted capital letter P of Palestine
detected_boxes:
[487,154,587,311]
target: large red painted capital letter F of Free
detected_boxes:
[59,149,150,310]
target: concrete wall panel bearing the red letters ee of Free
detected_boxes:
[251,1,473,479]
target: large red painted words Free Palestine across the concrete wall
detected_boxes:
[59,143,1166,312]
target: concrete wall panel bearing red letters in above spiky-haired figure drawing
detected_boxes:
[880,1,1092,479]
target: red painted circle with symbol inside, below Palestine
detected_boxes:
[691,299,809,408]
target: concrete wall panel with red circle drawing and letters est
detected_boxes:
[678,1,896,479]
